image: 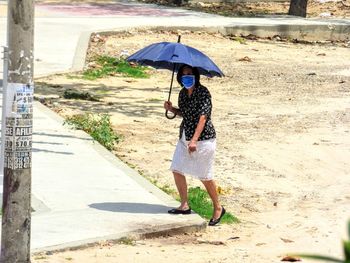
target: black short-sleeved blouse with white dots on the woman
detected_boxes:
[178,85,216,141]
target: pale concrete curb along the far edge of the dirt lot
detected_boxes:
[69,23,350,75]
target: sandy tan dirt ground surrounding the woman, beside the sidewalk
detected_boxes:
[33,31,350,263]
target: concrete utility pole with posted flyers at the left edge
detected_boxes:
[0,0,34,263]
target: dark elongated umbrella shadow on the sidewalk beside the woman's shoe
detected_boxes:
[89,202,169,214]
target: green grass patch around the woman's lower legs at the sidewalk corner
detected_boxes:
[188,187,239,224]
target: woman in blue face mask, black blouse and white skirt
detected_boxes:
[164,65,225,226]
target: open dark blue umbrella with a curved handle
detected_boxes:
[127,36,224,119]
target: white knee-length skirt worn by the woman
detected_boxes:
[170,133,216,181]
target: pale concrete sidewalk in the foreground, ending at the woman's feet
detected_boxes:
[32,103,206,251]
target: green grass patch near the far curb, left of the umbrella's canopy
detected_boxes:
[83,56,149,80]
